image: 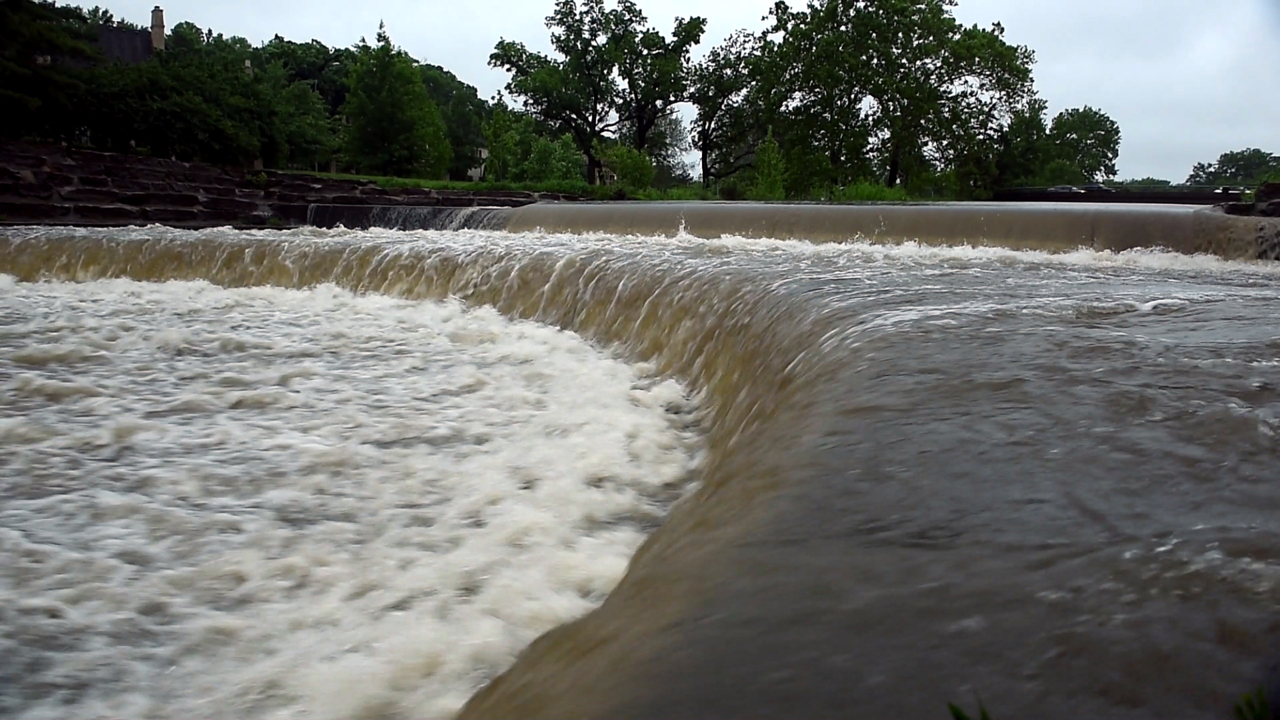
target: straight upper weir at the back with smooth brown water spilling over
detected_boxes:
[307,202,1280,260]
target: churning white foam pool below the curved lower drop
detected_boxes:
[0,275,696,717]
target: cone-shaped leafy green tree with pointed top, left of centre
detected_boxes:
[343,26,453,178]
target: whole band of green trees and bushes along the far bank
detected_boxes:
[0,0,1280,201]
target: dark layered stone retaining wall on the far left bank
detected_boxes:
[0,143,576,228]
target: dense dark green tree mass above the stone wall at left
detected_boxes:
[0,0,489,178]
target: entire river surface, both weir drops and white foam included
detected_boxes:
[0,204,1280,719]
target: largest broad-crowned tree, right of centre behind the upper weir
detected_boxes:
[765,0,1034,187]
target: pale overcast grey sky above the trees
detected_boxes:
[102,0,1280,182]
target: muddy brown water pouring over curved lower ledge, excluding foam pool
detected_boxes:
[0,222,1280,717]
